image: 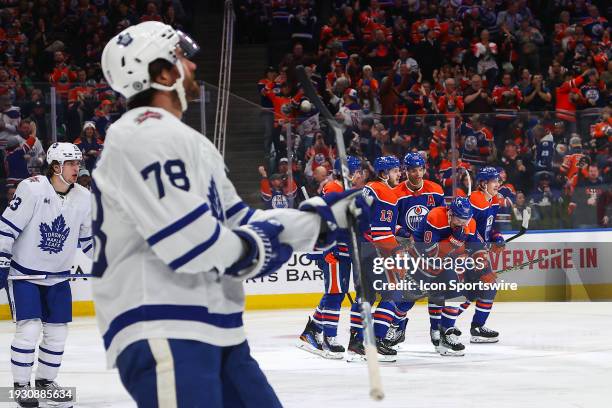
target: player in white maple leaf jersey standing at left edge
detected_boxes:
[0,143,93,407]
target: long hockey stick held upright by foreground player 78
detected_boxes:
[296,65,385,401]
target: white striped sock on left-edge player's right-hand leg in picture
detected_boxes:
[36,323,68,381]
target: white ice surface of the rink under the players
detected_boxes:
[0,303,612,408]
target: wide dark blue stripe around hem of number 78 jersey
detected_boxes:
[102,305,242,349]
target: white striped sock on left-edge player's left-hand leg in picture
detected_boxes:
[11,319,40,384]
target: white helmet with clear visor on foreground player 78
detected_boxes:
[101,21,200,111]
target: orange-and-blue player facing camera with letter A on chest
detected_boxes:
[387,153,444,344]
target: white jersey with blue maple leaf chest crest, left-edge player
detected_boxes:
[0,176,93,286]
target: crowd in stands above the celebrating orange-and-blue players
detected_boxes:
[250,0,612,229]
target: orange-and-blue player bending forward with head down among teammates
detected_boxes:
[414,197,482,356]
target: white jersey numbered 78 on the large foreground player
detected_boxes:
[92,107,320,366]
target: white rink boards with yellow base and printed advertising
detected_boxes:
[0,229,612,319]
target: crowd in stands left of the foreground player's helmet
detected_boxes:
[0,0,186,209]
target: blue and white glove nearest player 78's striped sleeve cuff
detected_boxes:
[225,219,293,280]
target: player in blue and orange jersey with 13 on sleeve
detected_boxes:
[348,156,400,362]
